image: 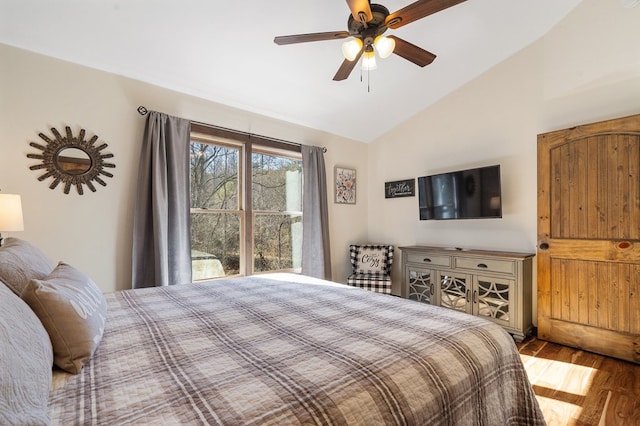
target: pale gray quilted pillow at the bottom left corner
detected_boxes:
[0,282,53,425]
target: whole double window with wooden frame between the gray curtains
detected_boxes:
[190,128,302,281]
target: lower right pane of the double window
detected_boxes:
[253,213,302,272]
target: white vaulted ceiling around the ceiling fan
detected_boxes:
[0,0,581,142]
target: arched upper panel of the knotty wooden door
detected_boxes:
[549,135,640,240]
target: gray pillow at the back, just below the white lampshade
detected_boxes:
[0,237,55,296]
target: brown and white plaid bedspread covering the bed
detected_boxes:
[49,275,544,426]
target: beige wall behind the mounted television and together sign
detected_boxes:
[369,0,640,302]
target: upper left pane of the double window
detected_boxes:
[191,142,239,210]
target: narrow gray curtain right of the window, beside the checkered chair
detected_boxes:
[301,145,331,280]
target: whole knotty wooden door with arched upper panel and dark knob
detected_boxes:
[537,115,640,363]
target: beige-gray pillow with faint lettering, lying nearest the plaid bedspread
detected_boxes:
[22,262,107,374]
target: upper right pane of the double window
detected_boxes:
[251,153,302,212]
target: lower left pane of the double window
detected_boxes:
[191,213,242,281]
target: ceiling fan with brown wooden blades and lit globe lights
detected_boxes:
[273,0,465,81]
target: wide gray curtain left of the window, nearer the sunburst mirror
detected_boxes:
[132,111,191,288]
